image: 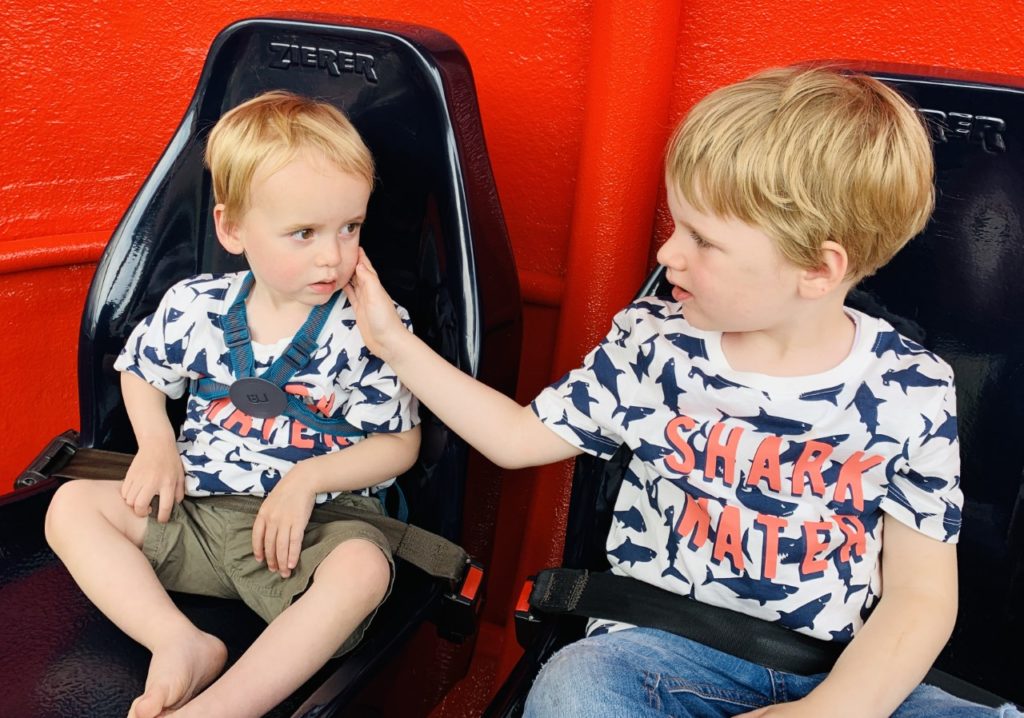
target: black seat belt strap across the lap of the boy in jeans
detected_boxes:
[529,568,846,675]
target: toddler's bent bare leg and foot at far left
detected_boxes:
[46,479,227,716]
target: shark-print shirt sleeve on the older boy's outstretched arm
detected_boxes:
[530,307,640,459]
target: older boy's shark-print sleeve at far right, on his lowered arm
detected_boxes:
[882,372,964,543]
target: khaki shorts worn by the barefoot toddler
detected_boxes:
[142,494,394,656]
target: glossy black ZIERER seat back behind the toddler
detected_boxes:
[79,18,520,540]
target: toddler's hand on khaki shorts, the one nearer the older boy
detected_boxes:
[253,464,316,579]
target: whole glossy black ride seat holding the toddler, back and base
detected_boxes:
[0,17,520,718]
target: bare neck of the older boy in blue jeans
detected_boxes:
[722,302,857,377]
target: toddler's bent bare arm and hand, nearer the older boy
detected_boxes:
[253,426,420,578]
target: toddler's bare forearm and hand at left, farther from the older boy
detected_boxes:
[121,372,185,522]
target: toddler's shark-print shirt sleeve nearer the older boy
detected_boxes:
[344,304,420,433]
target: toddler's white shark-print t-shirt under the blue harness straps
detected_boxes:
[114,272,419,503]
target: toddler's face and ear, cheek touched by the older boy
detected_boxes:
[214,153,370,308]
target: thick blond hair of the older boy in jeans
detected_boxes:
[666,68,935,280]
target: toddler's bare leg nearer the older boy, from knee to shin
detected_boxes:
[174,539,391,718]
